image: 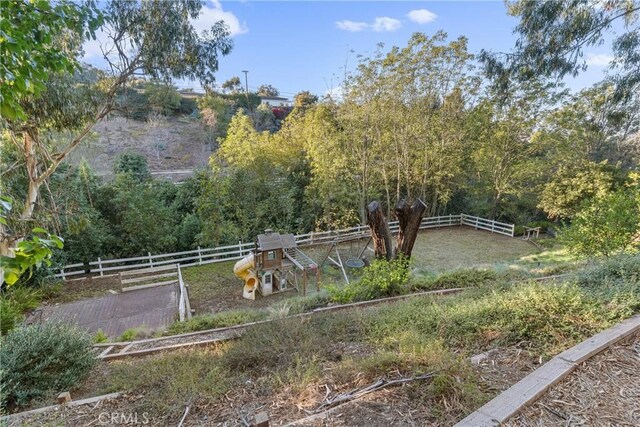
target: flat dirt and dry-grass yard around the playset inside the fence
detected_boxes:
[183,227,538,314]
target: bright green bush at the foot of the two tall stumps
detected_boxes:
[327,259,409,304]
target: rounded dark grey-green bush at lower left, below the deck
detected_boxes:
[0,322,96,406]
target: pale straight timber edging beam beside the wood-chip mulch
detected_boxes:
[456,316,640,427]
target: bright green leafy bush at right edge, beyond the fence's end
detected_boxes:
[559,191,640,257]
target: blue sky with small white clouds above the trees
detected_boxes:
[85,1,610,97]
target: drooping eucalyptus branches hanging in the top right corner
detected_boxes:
[480,0,640,99]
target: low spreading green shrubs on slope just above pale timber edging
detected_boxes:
[372,283,613,352]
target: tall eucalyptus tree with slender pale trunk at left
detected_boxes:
[2,0,232,253]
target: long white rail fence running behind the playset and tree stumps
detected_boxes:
[55,214,514,280]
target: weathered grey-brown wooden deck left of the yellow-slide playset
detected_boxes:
[34,285,179,337]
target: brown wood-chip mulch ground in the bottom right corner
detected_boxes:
[506,334,640,427]
